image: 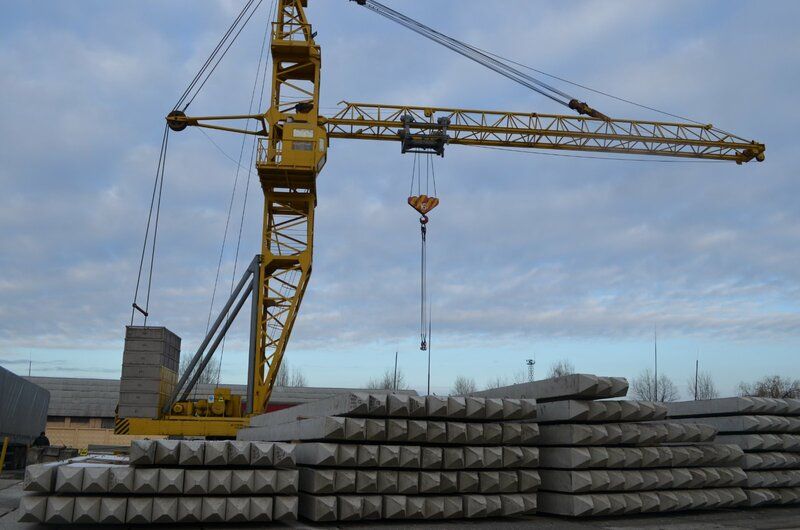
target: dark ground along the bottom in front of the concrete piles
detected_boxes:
[0,479,800,530]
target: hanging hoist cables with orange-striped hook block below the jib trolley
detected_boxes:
[408,153,439,351]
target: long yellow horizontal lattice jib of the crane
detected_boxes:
[322,102,765,163]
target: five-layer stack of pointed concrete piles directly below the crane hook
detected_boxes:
[239,394,539,522]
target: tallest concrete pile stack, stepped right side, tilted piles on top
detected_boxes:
[480,374,745,516]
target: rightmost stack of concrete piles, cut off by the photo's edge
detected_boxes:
[667,397,800,506]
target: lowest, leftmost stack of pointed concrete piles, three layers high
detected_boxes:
[20,440,298,525]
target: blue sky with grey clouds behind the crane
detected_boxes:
[0,0,800,398]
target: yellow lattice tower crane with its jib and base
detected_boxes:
[116,0,765,436]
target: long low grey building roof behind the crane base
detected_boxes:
[24,377,417,418]
